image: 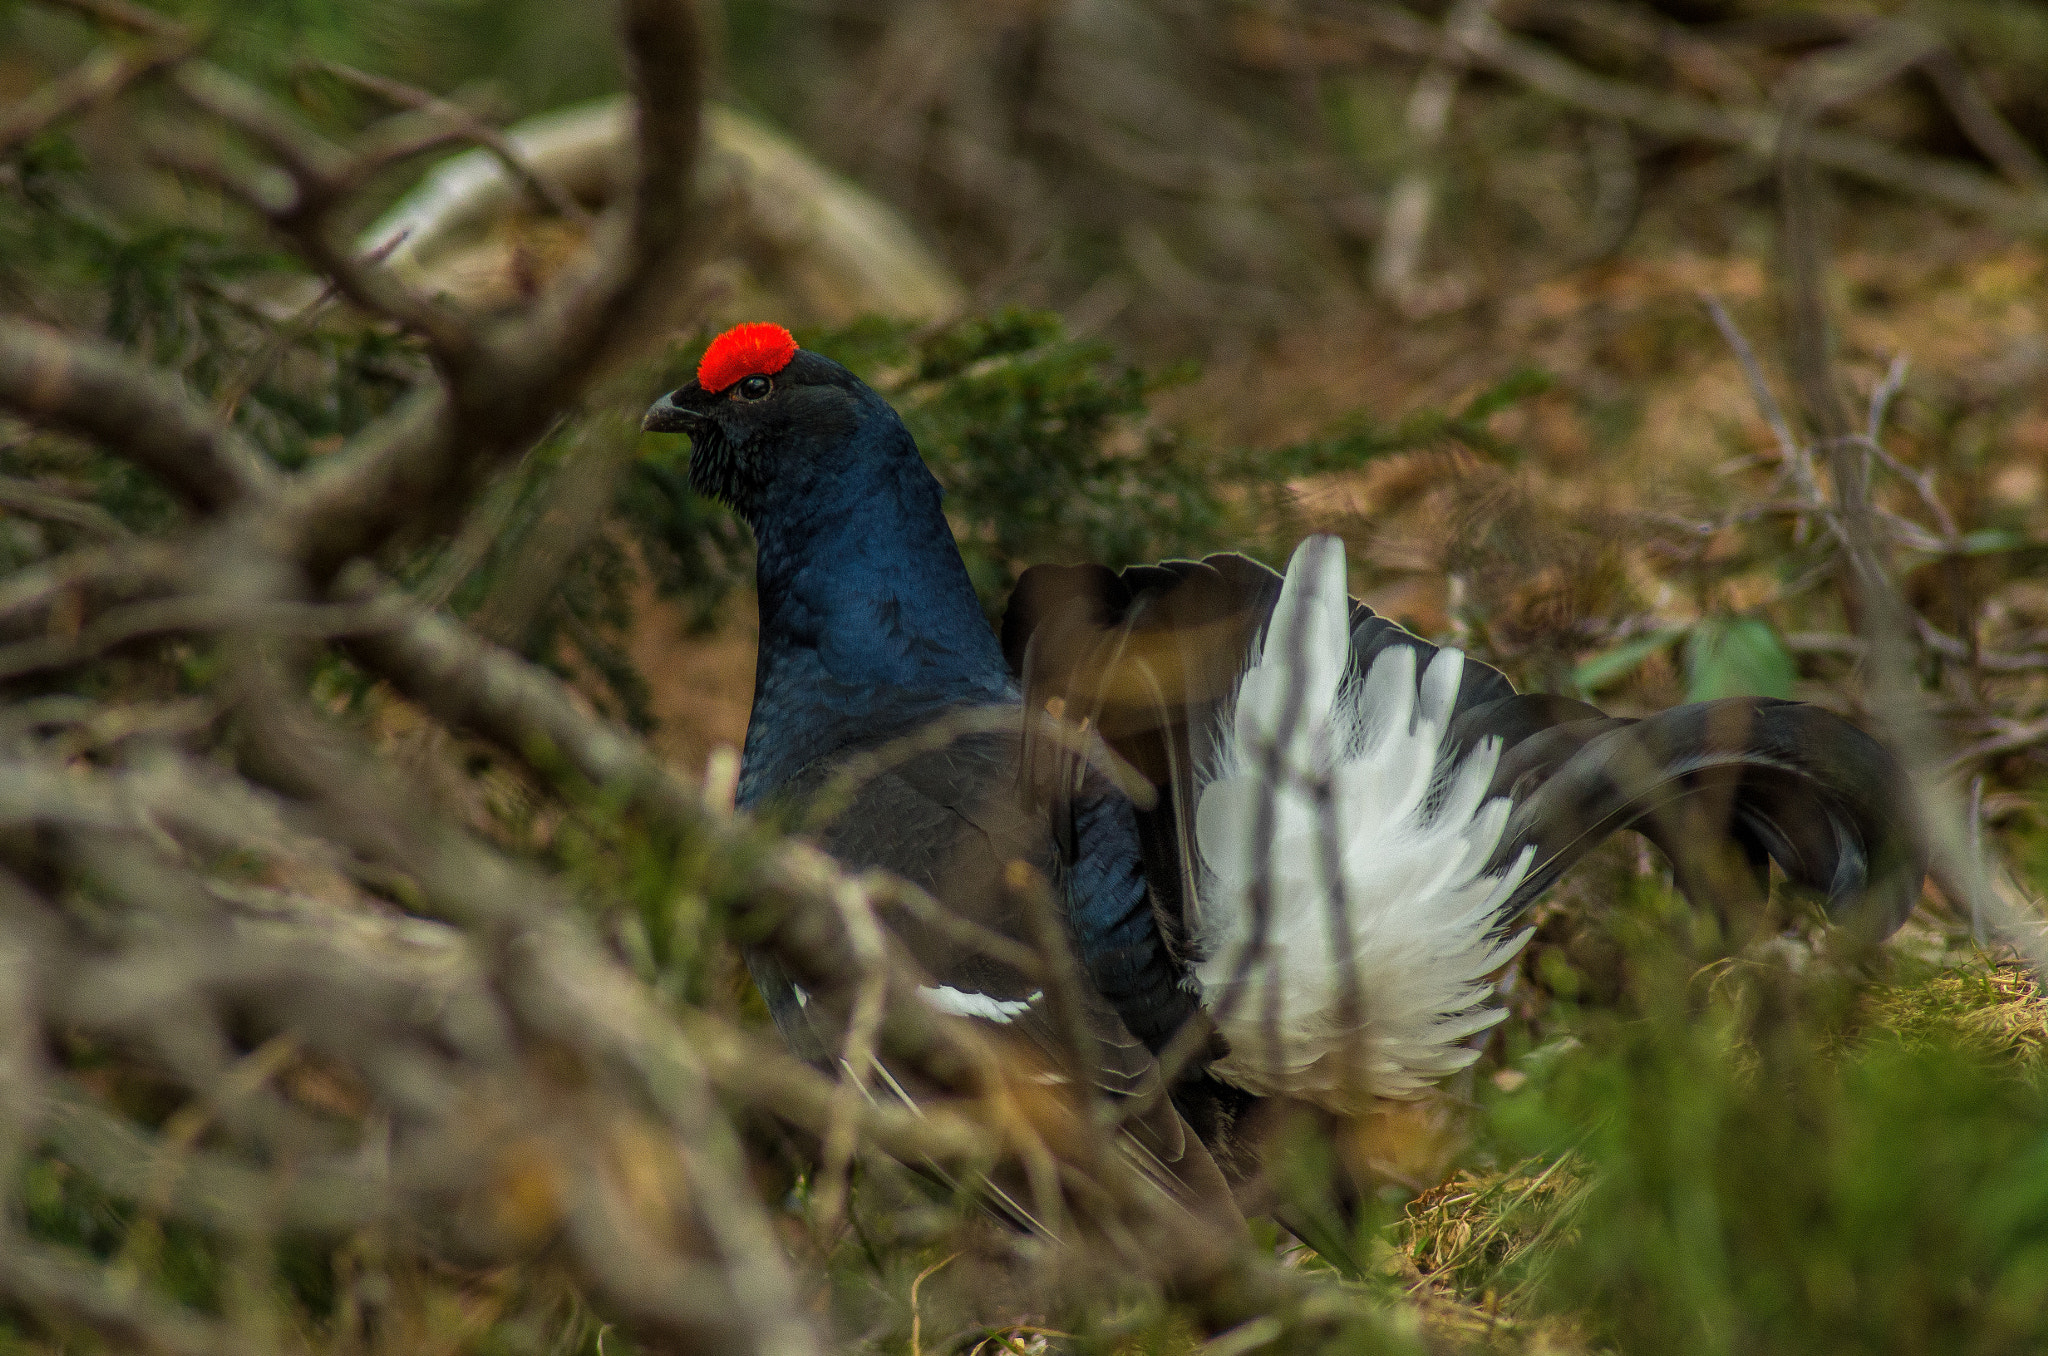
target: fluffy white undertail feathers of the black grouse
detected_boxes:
[1194,537,1534,1110]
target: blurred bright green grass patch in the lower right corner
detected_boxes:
[1449,929,2048,1354]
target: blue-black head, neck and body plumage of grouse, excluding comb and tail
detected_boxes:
[651,337,1227,1209]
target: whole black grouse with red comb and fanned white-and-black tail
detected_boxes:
[647,328,1919,1212]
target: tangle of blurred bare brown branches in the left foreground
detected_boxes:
[0,0,1350,1356]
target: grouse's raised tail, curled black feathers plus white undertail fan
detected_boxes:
[1004,539,1923,1104]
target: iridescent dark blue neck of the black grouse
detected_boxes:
[739,413,1016,805]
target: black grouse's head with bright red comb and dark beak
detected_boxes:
[641,324,922,526]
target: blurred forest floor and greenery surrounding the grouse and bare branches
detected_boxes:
[0,0,2048,1356]
